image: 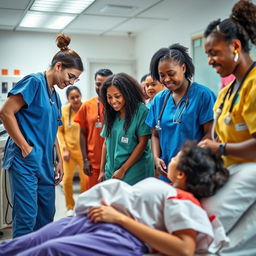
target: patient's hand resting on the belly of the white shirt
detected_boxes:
[87,200,126,224]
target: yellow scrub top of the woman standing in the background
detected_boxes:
[58,104,82,158]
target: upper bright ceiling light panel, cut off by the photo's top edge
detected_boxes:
[30,0,95,14]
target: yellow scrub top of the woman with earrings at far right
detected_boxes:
[214,67,256,167]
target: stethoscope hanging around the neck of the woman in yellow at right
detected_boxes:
[211,62,256,140]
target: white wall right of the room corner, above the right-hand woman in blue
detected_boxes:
[135,0,237,79]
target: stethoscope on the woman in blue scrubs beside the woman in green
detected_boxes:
[155,84,190,131]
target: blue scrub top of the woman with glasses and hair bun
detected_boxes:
[3,73,62,183]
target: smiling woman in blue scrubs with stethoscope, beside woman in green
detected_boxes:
[146,44,216,180]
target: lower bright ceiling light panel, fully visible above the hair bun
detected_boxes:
[19,11,75,29]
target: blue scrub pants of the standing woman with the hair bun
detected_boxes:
[8,161,55,238]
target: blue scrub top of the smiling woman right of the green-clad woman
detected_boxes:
[146,82,216,166]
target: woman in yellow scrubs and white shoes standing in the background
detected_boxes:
[58,86,87,217]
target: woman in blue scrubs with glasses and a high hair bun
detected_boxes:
[0,34,83,237]
